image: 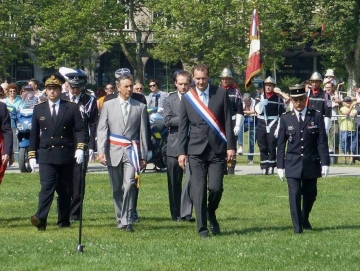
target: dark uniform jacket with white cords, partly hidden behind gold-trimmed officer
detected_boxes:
[61,93,99,150]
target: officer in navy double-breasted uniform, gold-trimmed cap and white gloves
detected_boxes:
[29,73,84,230]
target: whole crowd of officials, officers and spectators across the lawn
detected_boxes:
[0,64,360,238]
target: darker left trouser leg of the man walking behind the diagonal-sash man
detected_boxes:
[167,156,184,219]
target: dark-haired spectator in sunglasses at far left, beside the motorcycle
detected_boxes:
[6,83,21,160]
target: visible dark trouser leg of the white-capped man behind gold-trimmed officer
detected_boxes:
[70,162,85,220]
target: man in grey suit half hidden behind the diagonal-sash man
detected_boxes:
[162,71,195,222]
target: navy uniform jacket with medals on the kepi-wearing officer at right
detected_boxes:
[277,109,330,179]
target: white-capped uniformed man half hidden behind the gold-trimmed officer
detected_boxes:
[61,73,98,221]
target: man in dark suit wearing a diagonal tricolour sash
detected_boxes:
[178,64,236,238]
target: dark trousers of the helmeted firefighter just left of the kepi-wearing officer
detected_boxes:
[256,122,277,169]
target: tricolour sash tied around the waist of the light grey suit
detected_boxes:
[109,133,140,179]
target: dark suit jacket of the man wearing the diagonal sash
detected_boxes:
[179,85,236,155]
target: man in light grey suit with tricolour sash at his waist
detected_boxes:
[97,74,148,232]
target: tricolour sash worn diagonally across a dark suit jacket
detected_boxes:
[184,89,227,143]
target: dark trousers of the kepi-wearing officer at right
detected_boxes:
[287,178,317,233]
